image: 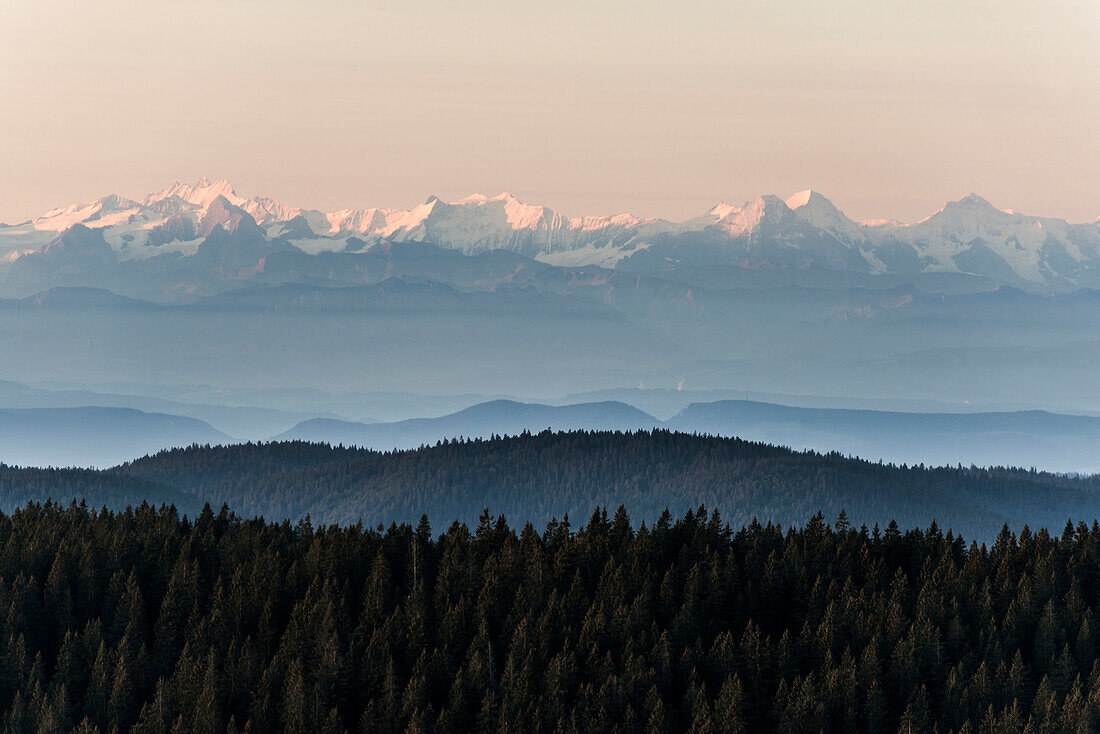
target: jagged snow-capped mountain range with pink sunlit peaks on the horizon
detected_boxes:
[0,178,1100,292]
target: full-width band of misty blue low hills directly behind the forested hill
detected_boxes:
[0,386,1100,474]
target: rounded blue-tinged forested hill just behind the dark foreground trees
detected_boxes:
[0,430,1100,539]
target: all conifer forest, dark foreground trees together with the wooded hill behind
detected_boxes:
[0,430,1100,734]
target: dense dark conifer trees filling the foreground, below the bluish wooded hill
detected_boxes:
[0,504,1100,734]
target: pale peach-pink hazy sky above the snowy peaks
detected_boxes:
[0,0,1100,221]
